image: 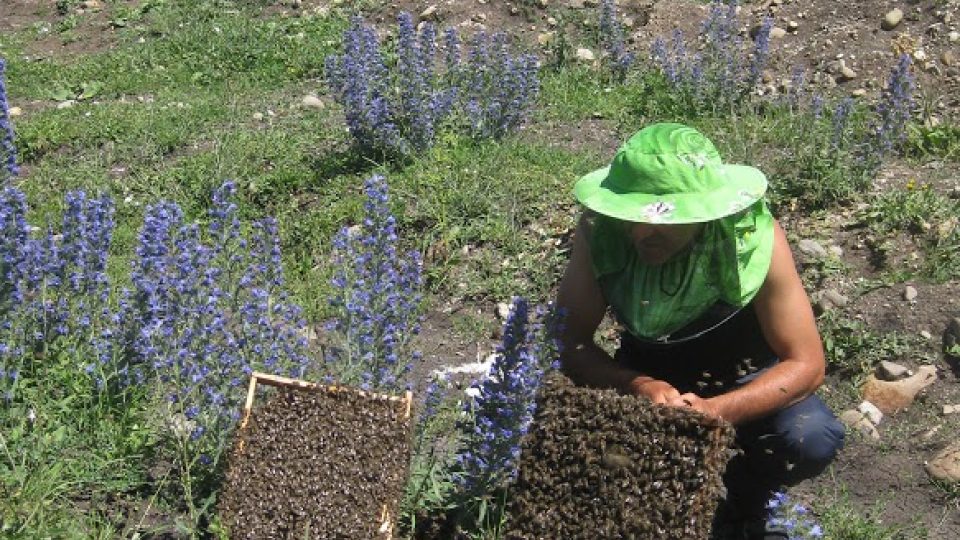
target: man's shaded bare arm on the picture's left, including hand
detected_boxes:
[557,217,680,403]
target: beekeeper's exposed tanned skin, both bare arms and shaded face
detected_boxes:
[557,214,826,425]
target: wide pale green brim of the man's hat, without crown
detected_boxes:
[573,164,767,224]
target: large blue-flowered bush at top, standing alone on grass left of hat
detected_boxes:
[325,12,540,159]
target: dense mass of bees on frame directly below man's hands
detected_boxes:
[505,374,734,540]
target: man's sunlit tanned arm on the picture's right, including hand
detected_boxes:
[671,224,826,425]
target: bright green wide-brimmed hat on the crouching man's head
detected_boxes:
[574,123,767,224]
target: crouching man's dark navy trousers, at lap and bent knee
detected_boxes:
[616,347,844,519]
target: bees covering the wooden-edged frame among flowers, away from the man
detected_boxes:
[218,388,410,539]
